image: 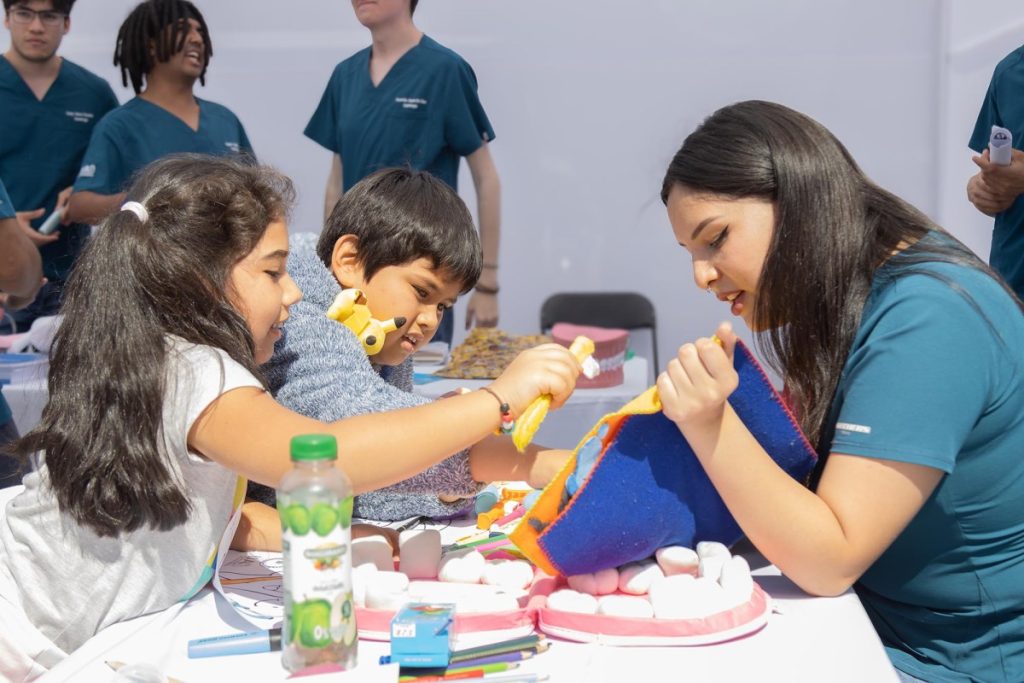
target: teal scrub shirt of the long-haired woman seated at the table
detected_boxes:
[822,249,1024,681]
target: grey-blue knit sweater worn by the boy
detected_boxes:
[249,232,480,520]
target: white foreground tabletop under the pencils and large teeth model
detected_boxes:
[45,522,897,683]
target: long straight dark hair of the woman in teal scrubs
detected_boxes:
[662,101,1019,452]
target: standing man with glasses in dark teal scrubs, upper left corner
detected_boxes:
[0,0,118,329]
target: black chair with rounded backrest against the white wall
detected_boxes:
[541,292,660,377]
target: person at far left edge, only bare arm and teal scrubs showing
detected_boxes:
[0,180,43,488]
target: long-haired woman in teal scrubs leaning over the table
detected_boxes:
[657,101,1024,682]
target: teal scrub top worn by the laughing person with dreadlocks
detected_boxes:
[75,97,253,195]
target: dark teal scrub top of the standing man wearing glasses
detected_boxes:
[0,56,118,283]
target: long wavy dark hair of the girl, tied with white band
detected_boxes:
[11,155,294,537]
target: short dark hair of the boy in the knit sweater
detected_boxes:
[316,168,483,294]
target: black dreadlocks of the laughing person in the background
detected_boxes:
[114,0,213,94]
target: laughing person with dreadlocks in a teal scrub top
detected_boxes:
[68,0,253,224]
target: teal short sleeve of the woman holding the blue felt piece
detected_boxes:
[831,275,999,473]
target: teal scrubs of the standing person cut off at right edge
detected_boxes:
[968,46,1024,297]
